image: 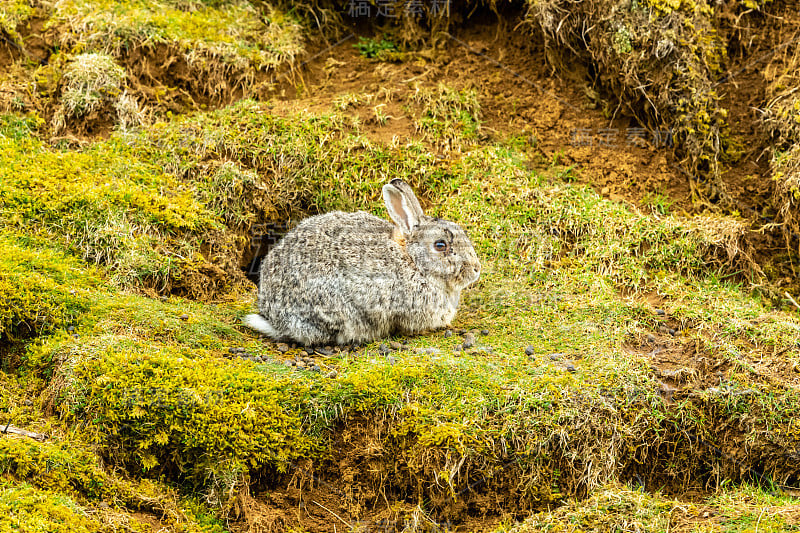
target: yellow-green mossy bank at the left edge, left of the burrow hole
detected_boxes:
[0,122,241,291]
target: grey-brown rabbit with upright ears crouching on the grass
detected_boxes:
[244,179,481,346]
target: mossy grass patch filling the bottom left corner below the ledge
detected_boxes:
[0,433,225,533]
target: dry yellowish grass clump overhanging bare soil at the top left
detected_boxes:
[48,0,304,98]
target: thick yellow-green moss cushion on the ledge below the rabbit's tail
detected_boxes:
[50,336,320,484]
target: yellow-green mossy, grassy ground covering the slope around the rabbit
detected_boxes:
[0,2,800,531]
